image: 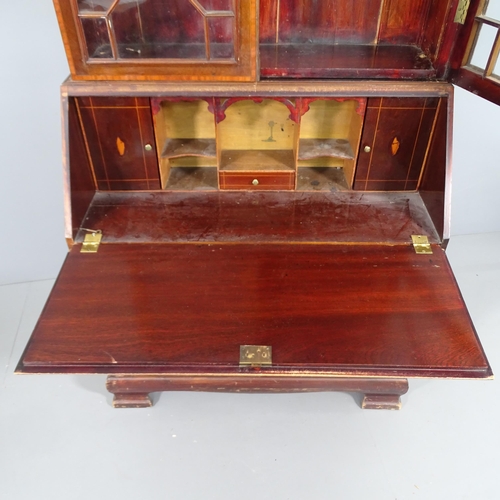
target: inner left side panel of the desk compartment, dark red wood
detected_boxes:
[68,99,95,238]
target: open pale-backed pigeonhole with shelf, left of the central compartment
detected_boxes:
[153,99,218,190]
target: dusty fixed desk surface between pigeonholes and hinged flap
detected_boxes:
[73,191,440,243]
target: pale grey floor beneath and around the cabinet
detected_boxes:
[0,233,500,500]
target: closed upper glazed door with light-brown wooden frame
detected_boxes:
[55,0,256,81]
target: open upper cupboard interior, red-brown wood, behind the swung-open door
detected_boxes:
[259,0,450,79]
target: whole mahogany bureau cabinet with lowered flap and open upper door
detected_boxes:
[18,0,500,409]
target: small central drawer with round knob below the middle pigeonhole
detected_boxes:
[219,172,295,190]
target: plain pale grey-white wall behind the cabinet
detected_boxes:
[0,0,500,285]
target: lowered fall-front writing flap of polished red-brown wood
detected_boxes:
[19,243,491,377]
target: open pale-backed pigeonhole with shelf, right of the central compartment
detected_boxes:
[297,98,366,191]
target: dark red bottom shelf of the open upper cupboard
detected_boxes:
[260,43,436,79]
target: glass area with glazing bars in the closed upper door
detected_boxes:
[76,0,236,62]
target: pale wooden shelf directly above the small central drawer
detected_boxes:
[220,149,295,172]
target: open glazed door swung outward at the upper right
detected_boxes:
[451,0,500,104]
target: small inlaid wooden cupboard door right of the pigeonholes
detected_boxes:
[354,97,439,191]
